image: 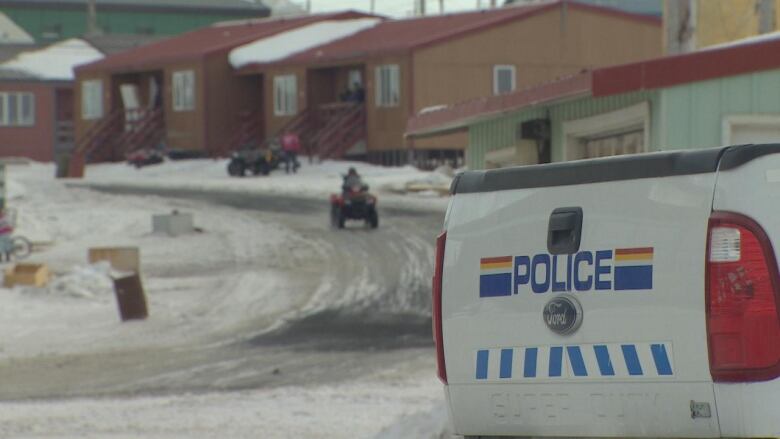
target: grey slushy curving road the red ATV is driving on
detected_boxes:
[0,183,442,400]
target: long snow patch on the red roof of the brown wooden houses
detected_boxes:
[230,18,382,69]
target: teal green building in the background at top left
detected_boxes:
[0,0,271,44]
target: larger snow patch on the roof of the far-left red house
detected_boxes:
[0,38,103,81]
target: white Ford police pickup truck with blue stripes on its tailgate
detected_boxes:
[433,145,780,437]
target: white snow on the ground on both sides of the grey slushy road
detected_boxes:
[0,160,449,439]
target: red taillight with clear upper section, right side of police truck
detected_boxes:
[706,212,780,381]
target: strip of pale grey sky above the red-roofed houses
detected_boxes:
[293,0,494,17]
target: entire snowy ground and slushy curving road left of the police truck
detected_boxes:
[0,160,449,439]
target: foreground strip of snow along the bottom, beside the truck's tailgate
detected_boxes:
[0,364,449,439]
